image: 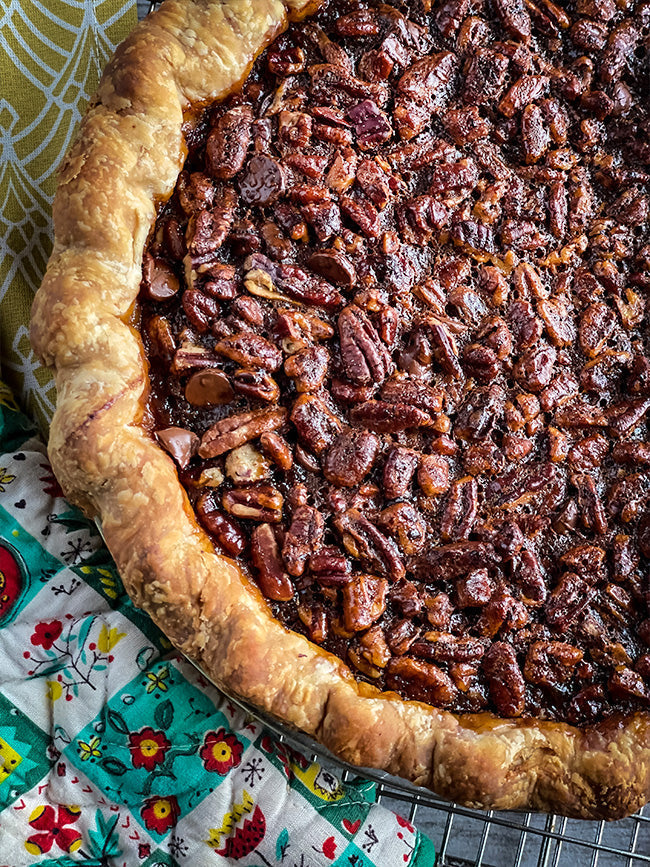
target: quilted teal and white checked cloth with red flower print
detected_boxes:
[0,385,435,867]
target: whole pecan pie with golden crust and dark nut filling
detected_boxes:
[32,0,650,818]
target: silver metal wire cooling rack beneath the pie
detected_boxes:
[137,0,650,867]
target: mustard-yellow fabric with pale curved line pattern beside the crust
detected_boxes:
[0,0,137,427]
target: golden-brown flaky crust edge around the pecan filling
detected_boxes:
[32,0,650,818]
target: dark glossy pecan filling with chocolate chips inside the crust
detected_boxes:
[141,0,650,724]
